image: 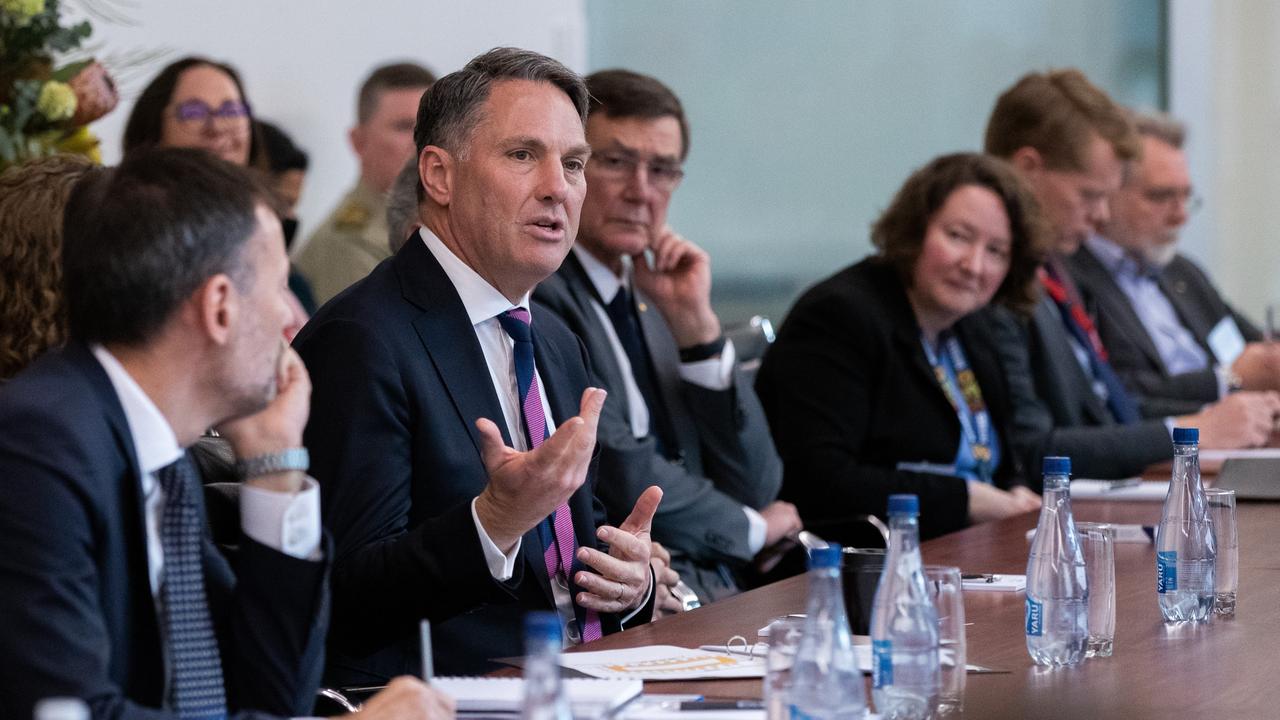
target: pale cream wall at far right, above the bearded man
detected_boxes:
[1170,0,1280,323]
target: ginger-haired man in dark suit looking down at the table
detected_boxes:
[986,69,1280,478]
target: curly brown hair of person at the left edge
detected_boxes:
[0,155,101,382]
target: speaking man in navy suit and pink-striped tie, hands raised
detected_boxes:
[296,49,662,684]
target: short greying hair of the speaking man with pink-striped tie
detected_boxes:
[413,47,589,200]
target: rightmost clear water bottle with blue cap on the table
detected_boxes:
[1156,428,1217,623]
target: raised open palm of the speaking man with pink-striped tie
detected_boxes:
[475,387,609,548]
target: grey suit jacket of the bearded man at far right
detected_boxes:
[1069,247,1262,418]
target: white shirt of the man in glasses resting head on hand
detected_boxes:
[573,245,768,555]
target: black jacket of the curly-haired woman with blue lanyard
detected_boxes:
[755,258,1025,539]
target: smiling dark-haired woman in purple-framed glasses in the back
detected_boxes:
[124,56,308,341]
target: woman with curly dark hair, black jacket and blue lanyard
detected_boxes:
[755,155,1047,542]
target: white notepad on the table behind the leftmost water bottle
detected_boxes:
[431,678,643,717]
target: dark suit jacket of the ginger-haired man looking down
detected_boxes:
[991,296,1172,478]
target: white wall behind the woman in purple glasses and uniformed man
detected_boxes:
[82,0,586,242]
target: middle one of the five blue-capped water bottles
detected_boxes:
[872,495,942,720]
